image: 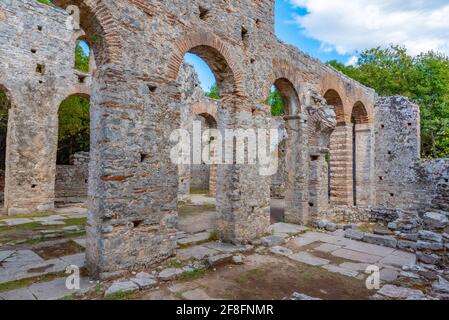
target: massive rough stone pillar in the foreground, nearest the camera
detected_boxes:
[86,69,180,278]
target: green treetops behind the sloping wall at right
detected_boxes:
[329,46,449,158]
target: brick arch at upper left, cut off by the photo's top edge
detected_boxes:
[53,0,122,64]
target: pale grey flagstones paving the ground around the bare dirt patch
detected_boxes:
[0,202,430,300]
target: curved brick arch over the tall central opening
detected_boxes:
[167,31,245,96]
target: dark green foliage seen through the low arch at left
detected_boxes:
[58,96,90,164]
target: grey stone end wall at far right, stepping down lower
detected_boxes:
[375,97,449,211]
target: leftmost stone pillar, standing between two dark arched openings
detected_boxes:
[5,87,59,215]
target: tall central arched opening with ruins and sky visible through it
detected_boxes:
[171,41,235,238]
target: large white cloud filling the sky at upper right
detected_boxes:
[290,0,449,55]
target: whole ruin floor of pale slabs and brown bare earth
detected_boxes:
[0,195,440,300]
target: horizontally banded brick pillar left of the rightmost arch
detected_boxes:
[330,125,354,206]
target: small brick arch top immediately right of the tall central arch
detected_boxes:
[262,59,304,115]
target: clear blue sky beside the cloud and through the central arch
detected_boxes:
[185,0,351,91]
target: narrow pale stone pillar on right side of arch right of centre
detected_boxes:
[285,114,309,224]
